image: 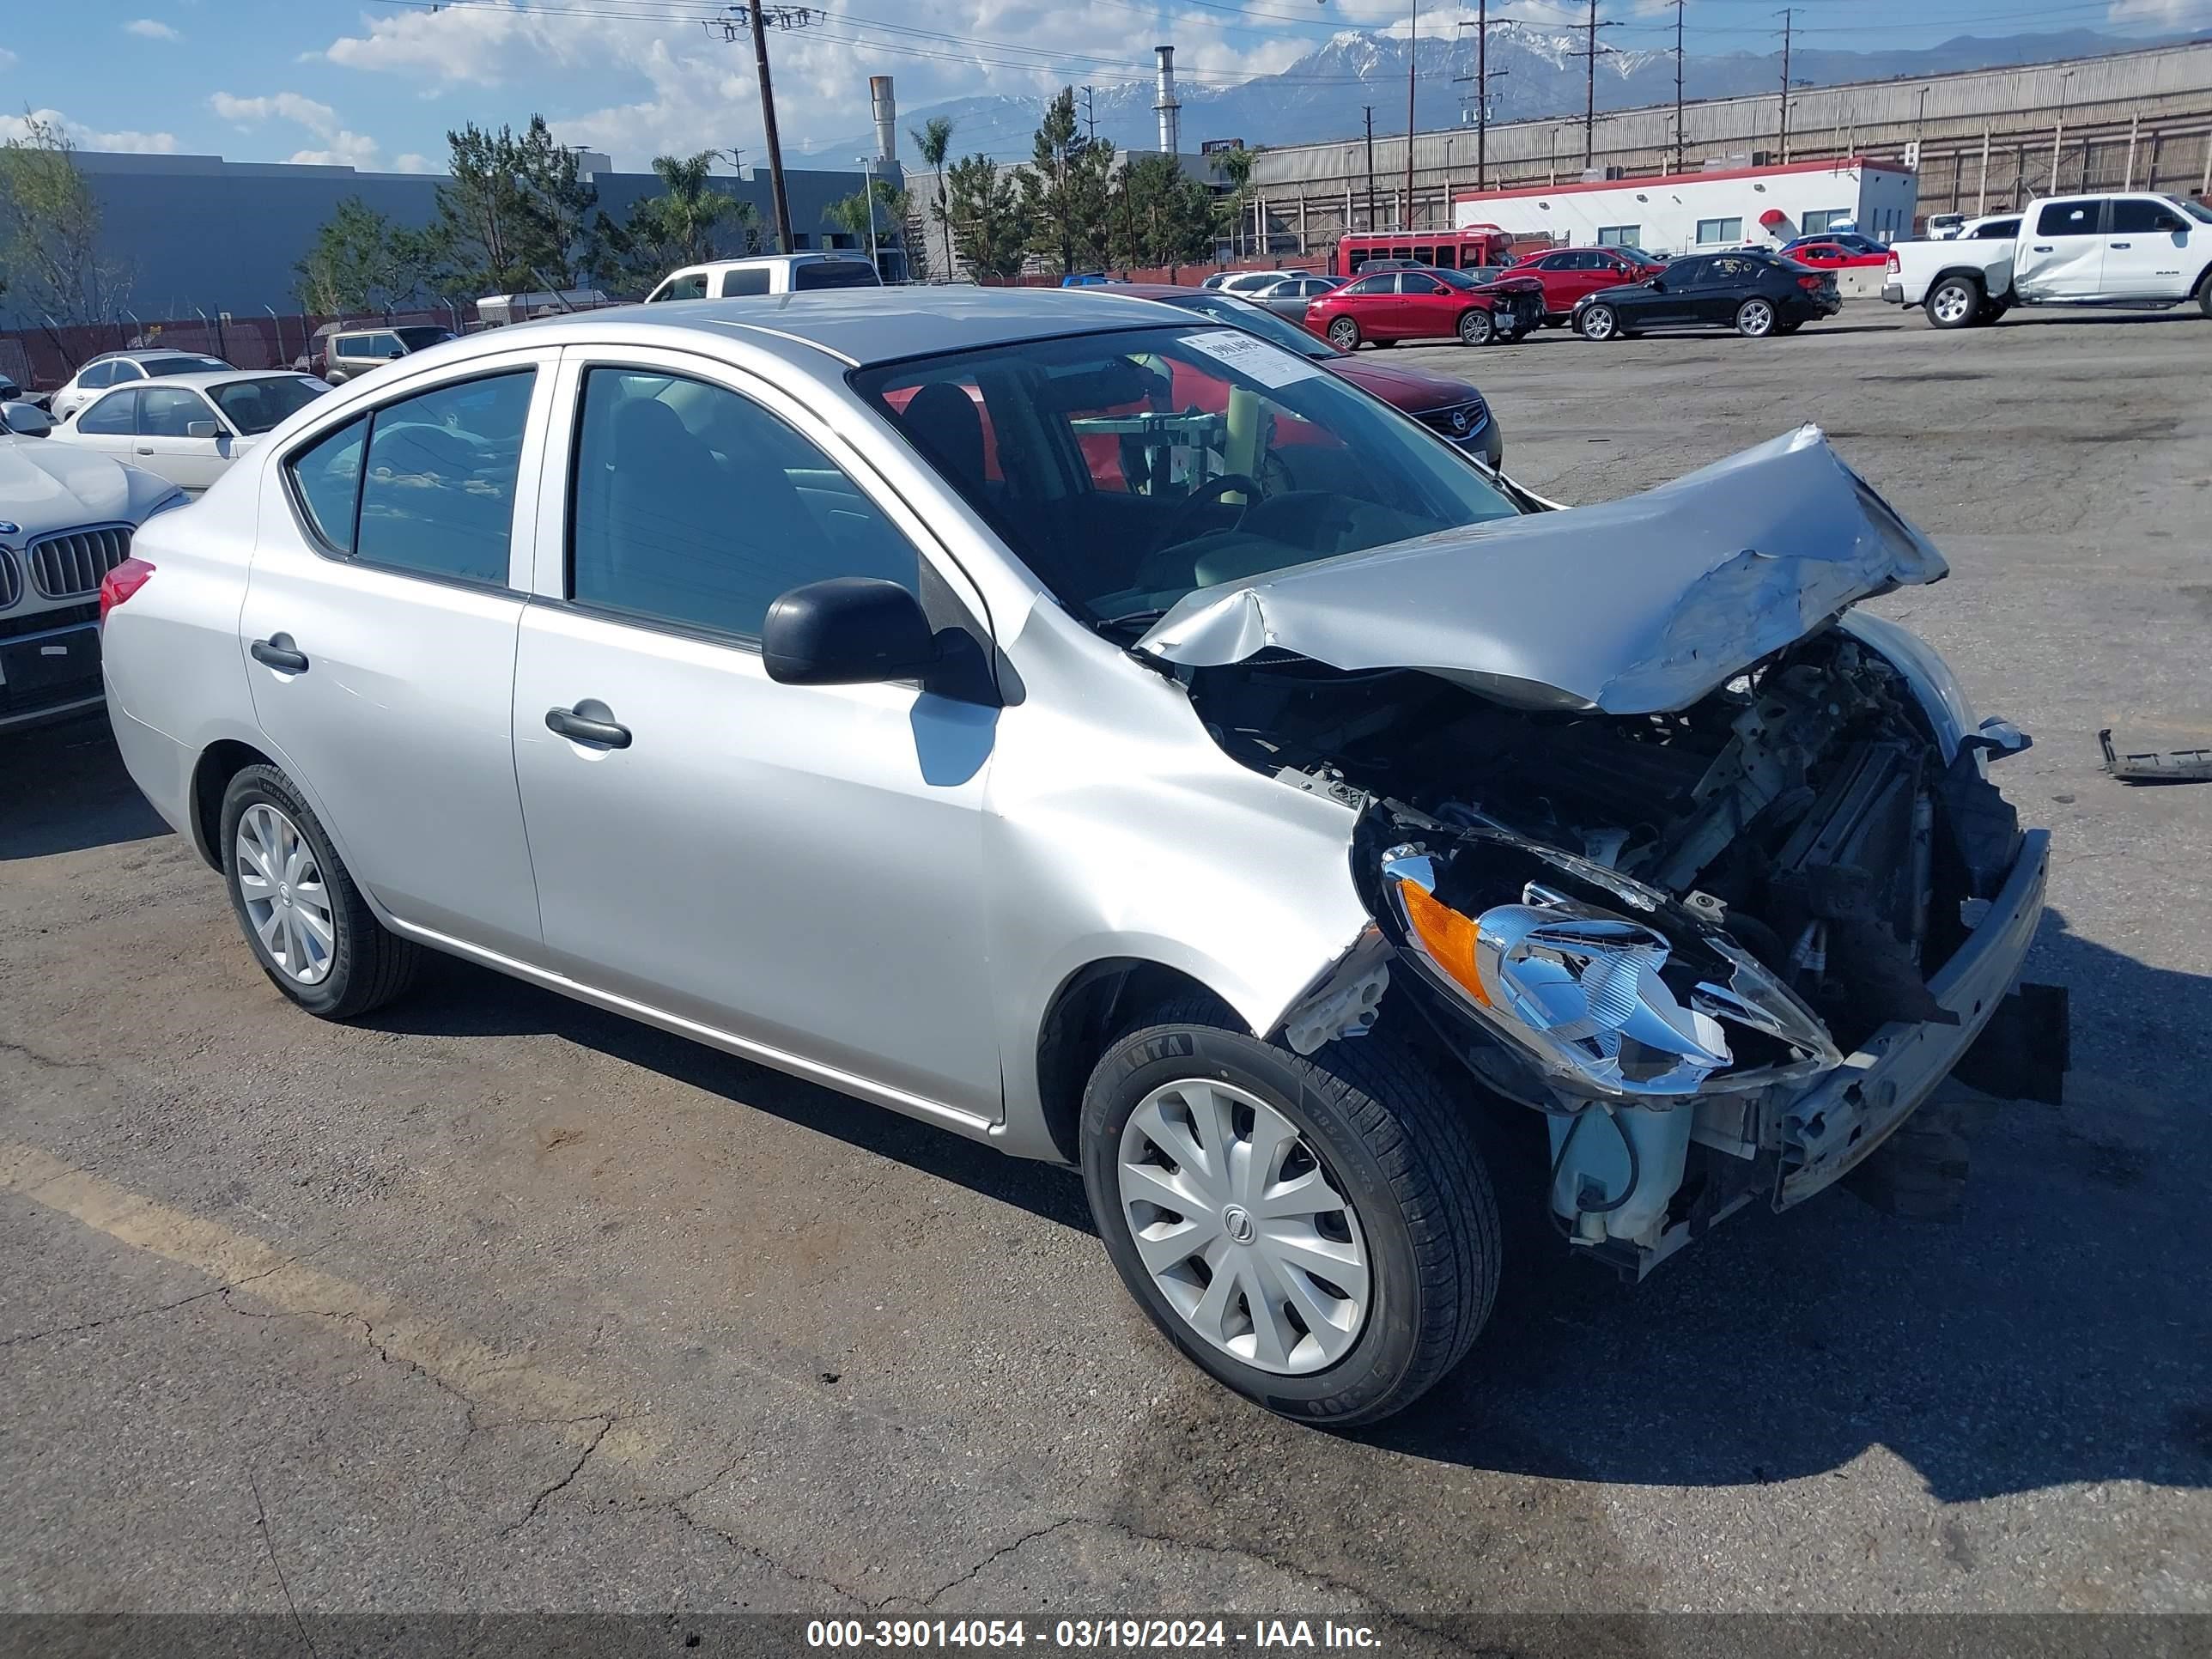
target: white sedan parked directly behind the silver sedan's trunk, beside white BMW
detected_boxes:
[53,369,330,495]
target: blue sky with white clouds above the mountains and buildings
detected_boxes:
[0,0,2212,170]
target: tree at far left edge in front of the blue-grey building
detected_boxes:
[0,111,131,327]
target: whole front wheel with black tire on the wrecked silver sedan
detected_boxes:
[1082,1002,1500,1427]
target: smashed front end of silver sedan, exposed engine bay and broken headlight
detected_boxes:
[1188,445,2066,1274]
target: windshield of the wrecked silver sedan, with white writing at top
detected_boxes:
[852,327,1520,633]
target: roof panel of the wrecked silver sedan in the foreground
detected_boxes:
[501,285,1194,368]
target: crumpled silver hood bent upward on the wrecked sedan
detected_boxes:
[1134,427,1948,714]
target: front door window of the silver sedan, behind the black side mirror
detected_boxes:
[568,369,921,639]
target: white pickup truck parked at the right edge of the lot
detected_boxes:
[1882,192,2212,327]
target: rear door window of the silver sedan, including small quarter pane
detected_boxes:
[289,369,538,586]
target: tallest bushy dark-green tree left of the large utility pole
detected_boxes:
[438,115,604,292]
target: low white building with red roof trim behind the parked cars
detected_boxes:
[1451,166,1917,254]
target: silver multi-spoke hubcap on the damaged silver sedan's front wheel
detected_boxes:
[1119,1079,1370,1376]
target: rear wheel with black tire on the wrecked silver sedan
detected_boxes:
[222,765,422,1020]
